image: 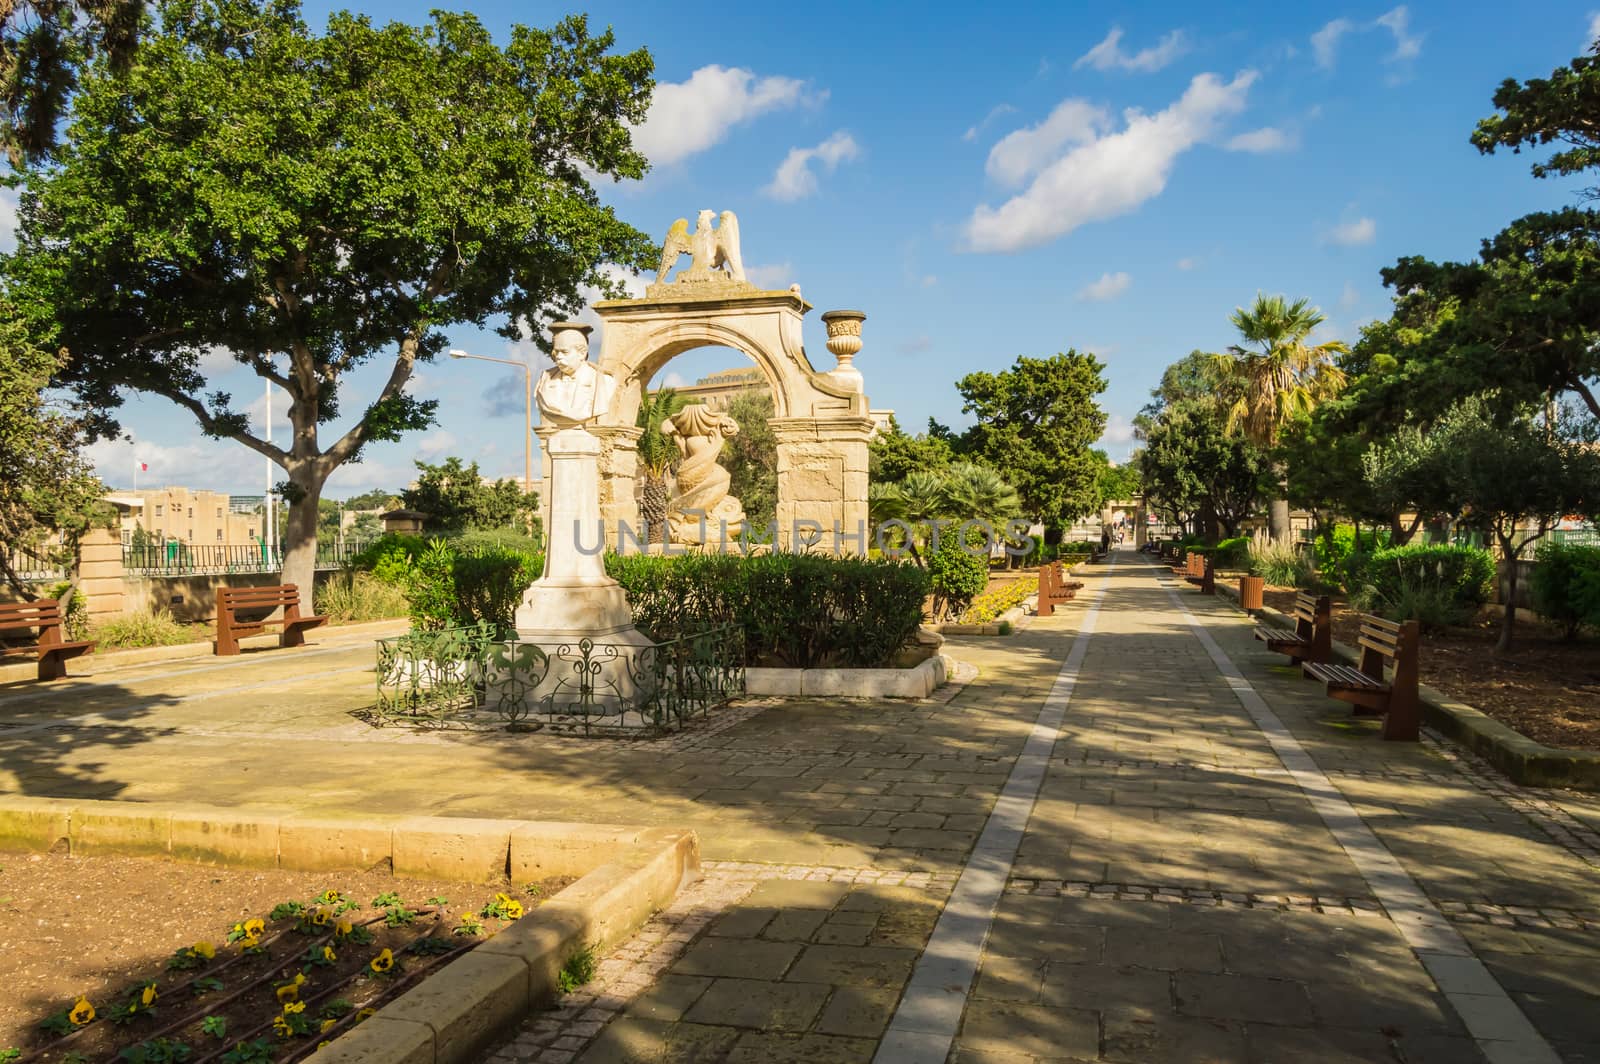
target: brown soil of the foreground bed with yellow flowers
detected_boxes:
[0,851,568,1064]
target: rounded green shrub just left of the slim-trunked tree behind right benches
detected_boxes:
[1346,544,1494,627]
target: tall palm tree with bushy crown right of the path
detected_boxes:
[1214,293,1350,541]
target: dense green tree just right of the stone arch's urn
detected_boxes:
[955,350,1106,534]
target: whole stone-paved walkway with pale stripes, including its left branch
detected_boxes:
[0,554,1600,1064]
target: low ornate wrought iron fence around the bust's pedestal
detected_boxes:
[374,622,744,736]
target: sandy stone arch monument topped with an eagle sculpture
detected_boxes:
[539,211,872,554]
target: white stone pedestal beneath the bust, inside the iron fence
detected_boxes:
[507,426,656,715]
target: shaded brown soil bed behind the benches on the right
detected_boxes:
[1264,587,1600,750]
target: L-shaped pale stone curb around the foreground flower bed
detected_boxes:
[0,795,699,1064]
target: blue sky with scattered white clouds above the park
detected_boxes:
[50,0,1600,498]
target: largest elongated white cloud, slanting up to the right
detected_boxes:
[966,70,1256,251]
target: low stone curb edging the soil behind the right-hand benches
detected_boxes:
[1216,581,1600,790]
